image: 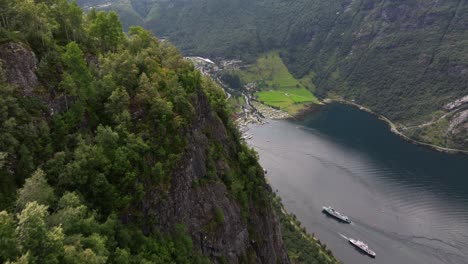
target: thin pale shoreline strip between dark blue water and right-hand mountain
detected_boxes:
[322,98,468,154]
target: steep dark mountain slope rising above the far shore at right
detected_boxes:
[300,1,468,148]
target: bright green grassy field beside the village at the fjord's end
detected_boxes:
[239,51,318,114]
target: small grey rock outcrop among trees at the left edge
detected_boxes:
[0,42,39,95]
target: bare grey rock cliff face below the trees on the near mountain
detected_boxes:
[143,88,289,263]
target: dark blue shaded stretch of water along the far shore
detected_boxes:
[306,104,468,200]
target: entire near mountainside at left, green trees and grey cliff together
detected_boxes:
[0,0,336,263]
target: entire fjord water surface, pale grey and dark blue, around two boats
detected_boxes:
[249,104,468,264]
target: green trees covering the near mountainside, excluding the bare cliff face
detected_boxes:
[0,0,218,263]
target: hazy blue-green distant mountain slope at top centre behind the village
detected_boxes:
[78,0,341,61]
